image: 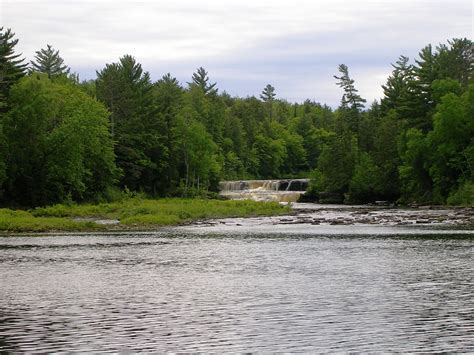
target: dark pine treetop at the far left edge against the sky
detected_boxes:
[0,27,28,105]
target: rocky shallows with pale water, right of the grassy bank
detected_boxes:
[180,203,474,234]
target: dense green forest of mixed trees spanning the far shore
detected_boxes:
[0,28,474,206]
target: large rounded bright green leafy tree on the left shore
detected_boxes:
[3,74,117,206]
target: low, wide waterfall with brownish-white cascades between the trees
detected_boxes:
[219,179,309,202]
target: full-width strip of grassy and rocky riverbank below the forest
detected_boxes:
[0,198,474,233]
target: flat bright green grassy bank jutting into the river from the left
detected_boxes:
[0,198,289,232]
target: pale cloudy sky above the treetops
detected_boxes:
[0,0,473,107]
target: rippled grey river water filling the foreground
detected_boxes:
[0,232,474,352]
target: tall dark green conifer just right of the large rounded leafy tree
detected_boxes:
[96,55,166,194]
